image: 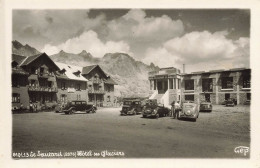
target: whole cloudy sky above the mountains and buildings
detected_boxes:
[13,9,250,72]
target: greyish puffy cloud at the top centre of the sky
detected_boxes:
[108,9,184,41]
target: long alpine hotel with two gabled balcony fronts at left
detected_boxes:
[12,53,116,110]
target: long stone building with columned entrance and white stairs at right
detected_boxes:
[149,67,251,106]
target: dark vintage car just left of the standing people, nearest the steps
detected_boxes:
[142,99,170,118]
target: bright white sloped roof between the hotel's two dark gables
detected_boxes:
[54,62,88,81]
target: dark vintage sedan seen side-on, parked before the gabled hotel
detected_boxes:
[62,100,97,114]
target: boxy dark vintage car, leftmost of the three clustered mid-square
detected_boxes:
[120,98,143,115]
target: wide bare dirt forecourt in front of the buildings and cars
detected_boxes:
[12,105,250,158]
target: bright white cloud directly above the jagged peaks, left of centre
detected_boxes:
[42,30,131,57]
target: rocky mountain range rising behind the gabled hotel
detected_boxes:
[12,41,159,97]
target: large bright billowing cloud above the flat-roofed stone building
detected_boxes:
[143,31,249,71]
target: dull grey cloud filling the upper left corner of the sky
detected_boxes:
[13,10,105,49]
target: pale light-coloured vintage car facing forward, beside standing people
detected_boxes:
[177,102,199,121]
